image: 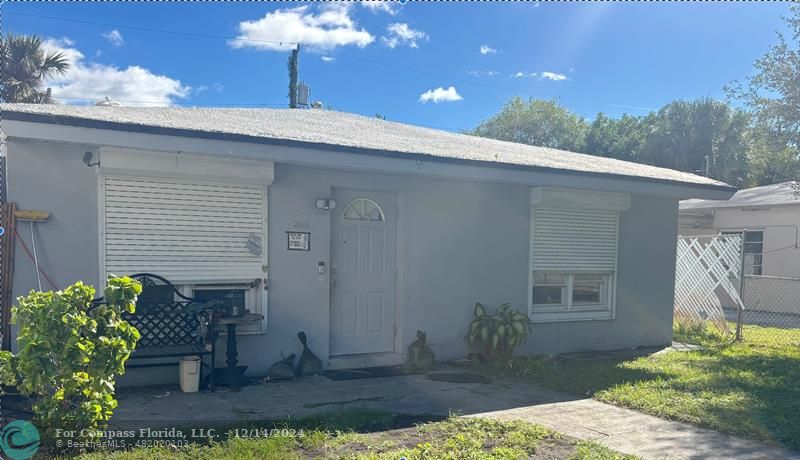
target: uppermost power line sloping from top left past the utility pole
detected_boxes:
[5,12,558,98]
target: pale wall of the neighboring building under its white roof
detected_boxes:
[680,205,800,278]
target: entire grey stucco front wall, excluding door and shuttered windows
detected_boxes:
[8,141,678,383]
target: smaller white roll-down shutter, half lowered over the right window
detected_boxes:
[531,207,619,272]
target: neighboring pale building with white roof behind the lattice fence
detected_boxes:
[678,182,800,278]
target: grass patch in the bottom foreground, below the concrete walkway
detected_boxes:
[76,412,634,460]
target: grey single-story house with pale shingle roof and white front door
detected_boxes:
[0,104,734,384]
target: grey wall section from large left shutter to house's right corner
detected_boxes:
[227,165,677,376]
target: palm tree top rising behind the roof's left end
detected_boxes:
[0,34,69,104]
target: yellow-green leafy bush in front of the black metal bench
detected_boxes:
[0,277,142,448]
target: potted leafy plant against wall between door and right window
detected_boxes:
[465,303,531,360]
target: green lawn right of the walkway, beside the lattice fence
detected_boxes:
[482,326,800,451]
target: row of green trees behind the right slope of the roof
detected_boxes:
[473,98,750,186]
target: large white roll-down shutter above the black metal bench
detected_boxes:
[103,176,266,284]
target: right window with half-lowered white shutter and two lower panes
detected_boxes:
[529,189,629,322]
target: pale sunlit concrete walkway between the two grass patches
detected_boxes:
[471,399,800,460]
